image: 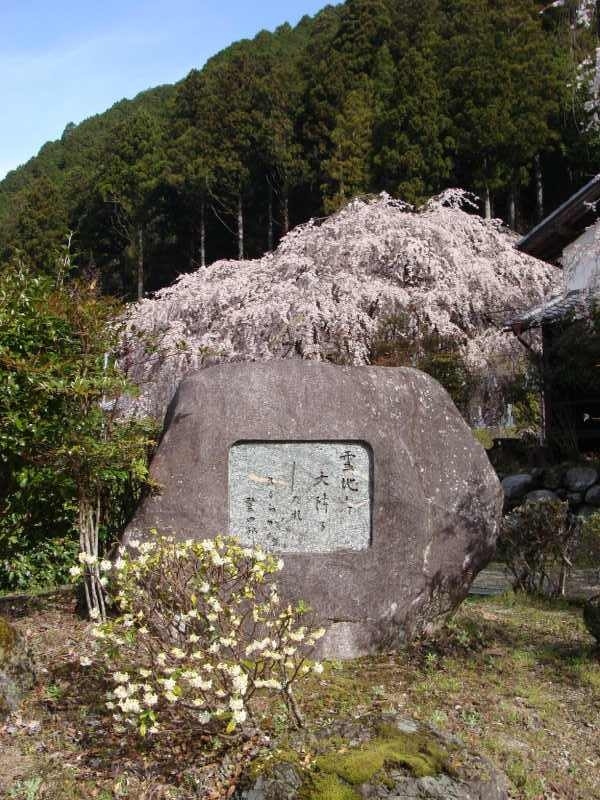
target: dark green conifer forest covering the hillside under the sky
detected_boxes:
[0,0,600,297]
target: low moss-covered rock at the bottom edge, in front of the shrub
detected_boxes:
[234,714,508,800]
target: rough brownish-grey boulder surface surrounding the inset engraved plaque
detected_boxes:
[125,361,503,658]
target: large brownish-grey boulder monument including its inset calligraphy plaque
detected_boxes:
[126,361,502,657]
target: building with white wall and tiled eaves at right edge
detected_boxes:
[506,175,600,451]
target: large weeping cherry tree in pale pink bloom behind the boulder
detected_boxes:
[121,190,560,418]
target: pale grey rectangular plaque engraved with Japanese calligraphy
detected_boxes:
[229,442,372,553]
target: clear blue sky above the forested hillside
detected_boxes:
[0,0,326,178]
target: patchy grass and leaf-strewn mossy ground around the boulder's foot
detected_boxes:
[0,595,600,800]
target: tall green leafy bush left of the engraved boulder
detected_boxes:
[0,252,155,600]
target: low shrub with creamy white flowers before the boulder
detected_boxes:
[82,537,325,736]
